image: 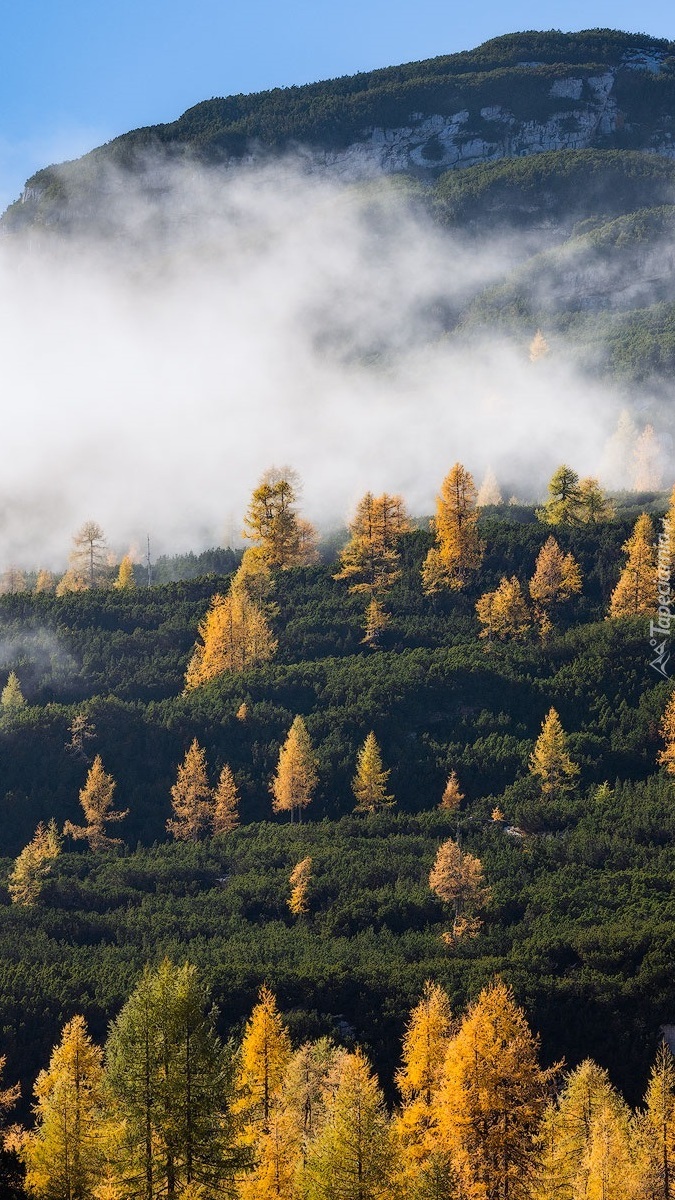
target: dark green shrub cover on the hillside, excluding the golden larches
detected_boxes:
[0,496,675,1113]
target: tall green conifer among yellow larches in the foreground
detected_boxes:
[106,959,244,1200]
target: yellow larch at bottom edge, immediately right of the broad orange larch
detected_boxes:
[532,1058,623,1200]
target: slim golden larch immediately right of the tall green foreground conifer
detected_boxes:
[233,984,291,1145]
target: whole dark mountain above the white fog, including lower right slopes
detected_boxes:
[6,29,675,386]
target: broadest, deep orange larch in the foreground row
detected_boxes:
[440,980,555,1200]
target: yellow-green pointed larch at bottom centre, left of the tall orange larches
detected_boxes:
[300,1050,393,1200]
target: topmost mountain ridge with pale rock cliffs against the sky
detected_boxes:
[4,29,675,228]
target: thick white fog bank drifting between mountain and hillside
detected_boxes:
[0,161,662,568]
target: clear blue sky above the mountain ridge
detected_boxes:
[0,0,675,208]
